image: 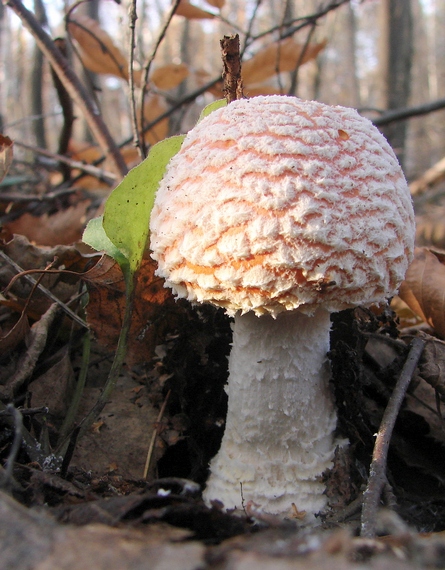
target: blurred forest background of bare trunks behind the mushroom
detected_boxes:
[0,0,445,240]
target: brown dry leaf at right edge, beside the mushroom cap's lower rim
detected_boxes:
[399,247,445,337]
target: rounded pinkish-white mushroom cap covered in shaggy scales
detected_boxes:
[150,95,414,316]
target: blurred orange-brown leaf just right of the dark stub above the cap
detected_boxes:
[243,38,326,88]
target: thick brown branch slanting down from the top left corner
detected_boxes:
[3,0,127,176]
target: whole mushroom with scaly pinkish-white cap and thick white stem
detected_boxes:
[151,96,414,519]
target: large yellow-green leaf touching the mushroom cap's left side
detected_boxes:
[99,135,185,273]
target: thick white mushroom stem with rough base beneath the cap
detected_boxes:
[204,309,336,520]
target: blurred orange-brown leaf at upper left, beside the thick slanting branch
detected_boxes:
[68,14,128,80]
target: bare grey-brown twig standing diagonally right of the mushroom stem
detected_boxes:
[360,337,425,538]
